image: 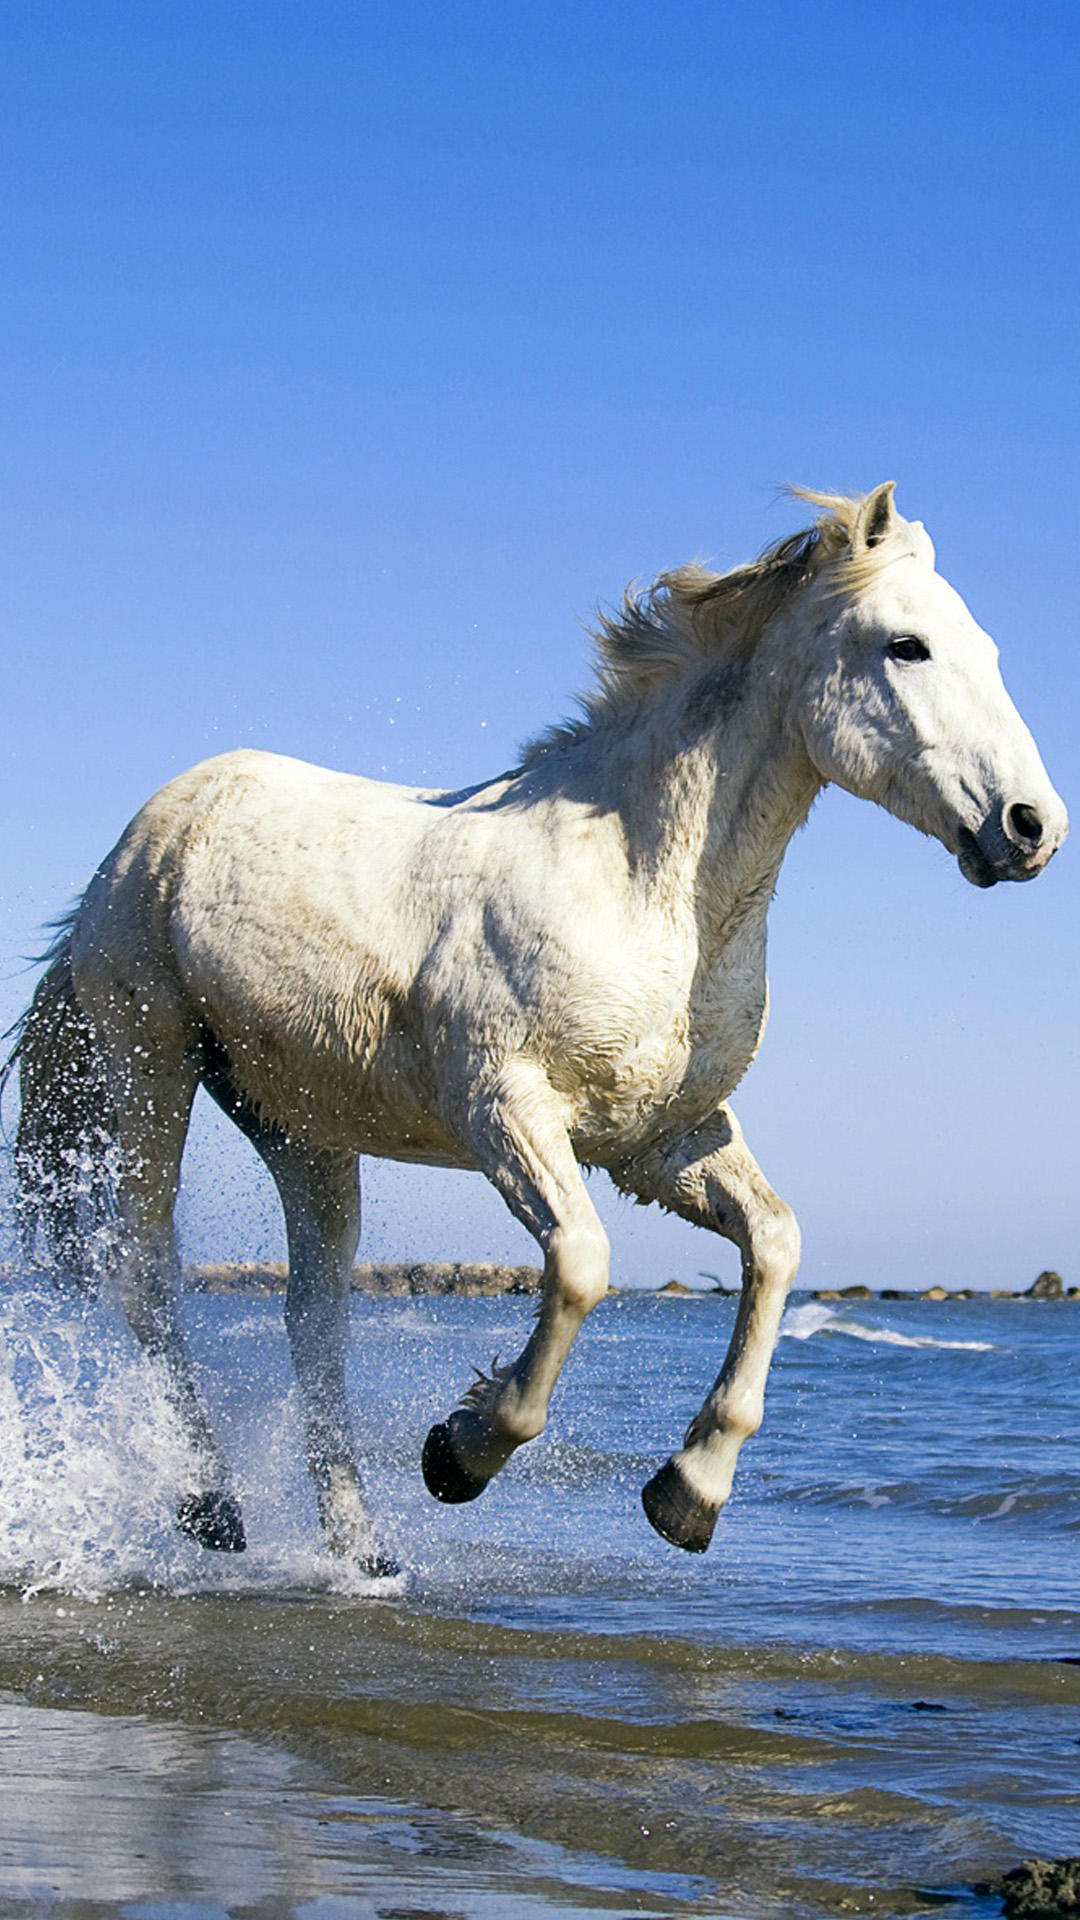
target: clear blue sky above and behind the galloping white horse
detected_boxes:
[0,0,1080,1284]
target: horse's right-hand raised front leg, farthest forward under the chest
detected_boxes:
[617,1108,799,1553]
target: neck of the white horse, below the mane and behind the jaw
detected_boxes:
[588,641,821,952]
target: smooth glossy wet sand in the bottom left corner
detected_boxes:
[0,1701,680,1920]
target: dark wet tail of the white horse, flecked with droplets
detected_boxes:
[0,906,115,1284]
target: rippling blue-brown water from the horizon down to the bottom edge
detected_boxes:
[0,1294,1080,1920]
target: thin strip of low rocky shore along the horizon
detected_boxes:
[176,1260,1080,1302]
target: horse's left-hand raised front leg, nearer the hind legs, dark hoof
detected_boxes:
[423,1062,611,1503]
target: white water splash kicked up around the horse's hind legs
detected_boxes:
[0,1286,402,1599]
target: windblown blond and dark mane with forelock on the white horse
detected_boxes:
[523,486,917,766]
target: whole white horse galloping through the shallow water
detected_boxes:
[4,484,1067,1569]
